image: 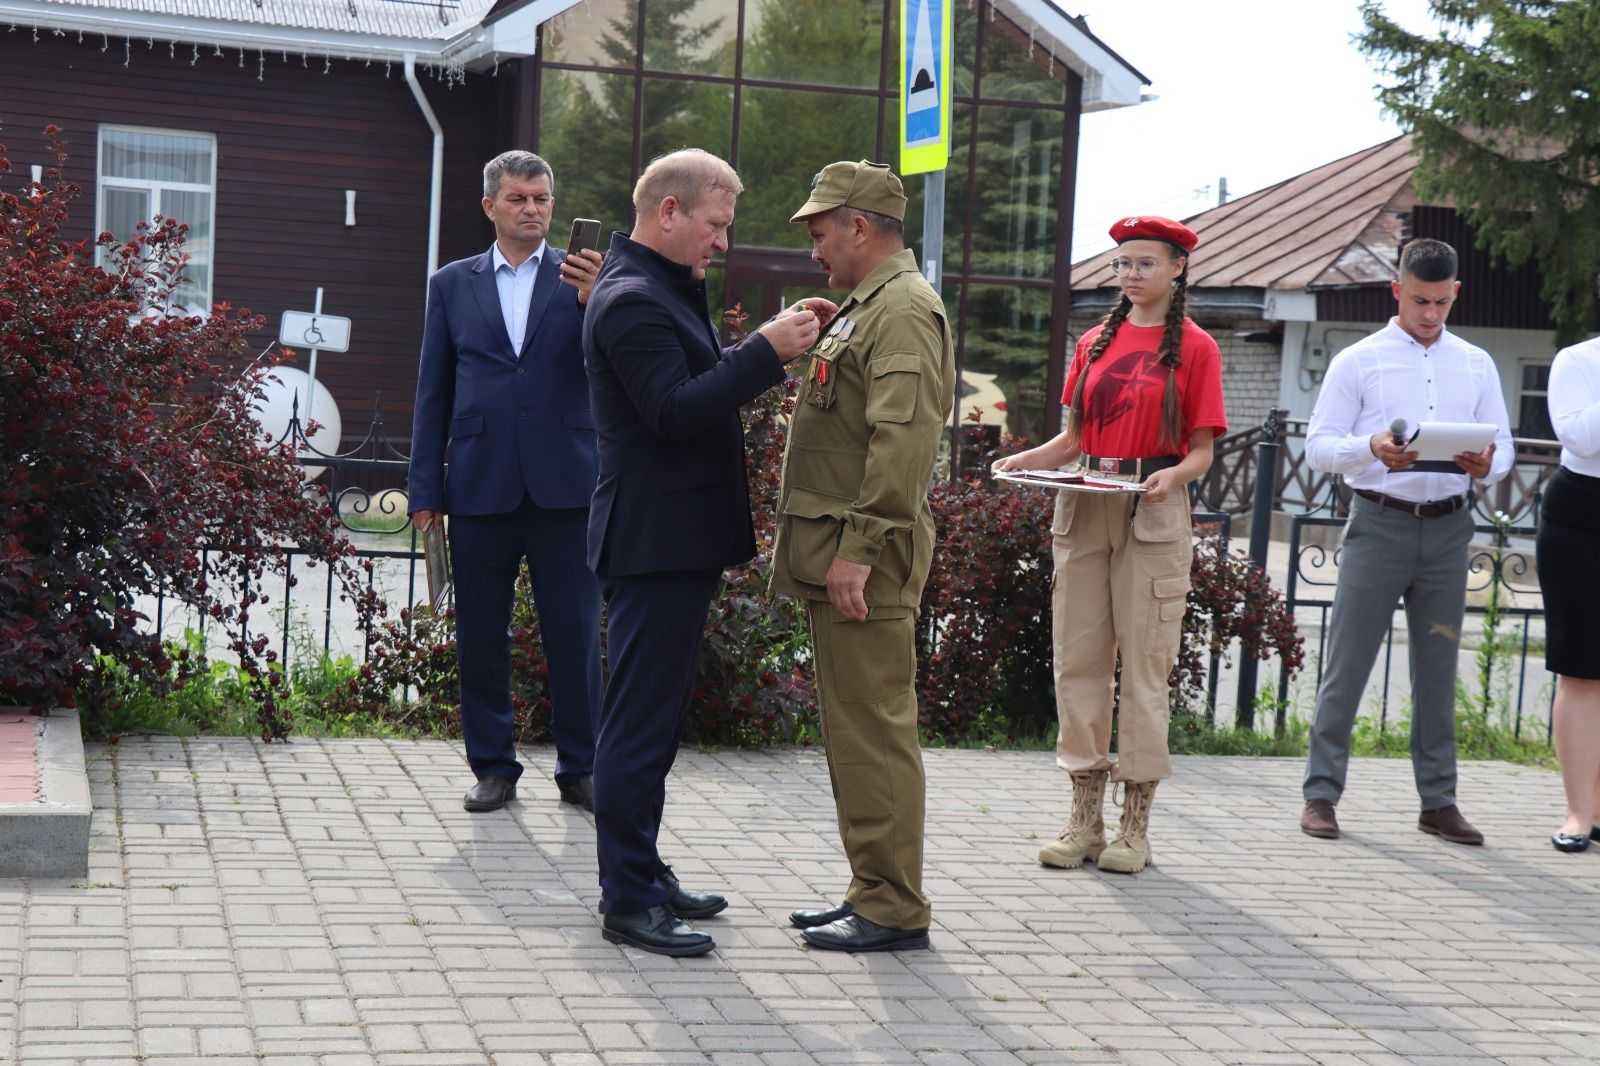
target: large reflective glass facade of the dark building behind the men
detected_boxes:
[534,0,1082,440]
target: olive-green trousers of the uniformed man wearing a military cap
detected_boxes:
[806,600,933,928]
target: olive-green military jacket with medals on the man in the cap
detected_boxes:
[771,248,955,608]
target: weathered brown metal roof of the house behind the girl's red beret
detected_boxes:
[1072,134,1416,291]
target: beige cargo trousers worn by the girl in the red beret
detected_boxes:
[1051,491,1194,781]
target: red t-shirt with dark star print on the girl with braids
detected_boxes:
[1061,319,1227,459]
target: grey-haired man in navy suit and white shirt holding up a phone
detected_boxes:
[410,150,602,812]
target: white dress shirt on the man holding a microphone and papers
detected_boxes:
[1306,319,1510,503]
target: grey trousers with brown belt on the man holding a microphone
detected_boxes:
[1304,496,1472,810]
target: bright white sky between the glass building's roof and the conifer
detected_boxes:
[1058,0,1432,261]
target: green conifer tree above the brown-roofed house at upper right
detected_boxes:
[1357,0,1600,343]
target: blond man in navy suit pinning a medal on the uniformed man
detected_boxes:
[584,149,832,956]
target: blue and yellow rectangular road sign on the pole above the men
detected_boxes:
[899,0,955,176]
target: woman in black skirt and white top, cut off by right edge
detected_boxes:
[1538,338,1600,852]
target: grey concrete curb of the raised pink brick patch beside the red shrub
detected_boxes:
[0,707,93,877]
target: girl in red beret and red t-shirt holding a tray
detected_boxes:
[994,216,1227,874]
